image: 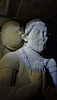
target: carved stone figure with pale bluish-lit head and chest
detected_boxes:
[0,21,57,100]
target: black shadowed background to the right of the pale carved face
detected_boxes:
[44,14,57,62]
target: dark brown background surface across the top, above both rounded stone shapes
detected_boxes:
[0,0,57,22]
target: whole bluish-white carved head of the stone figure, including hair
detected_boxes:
[23,21,48,53]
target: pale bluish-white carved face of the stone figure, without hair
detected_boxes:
[28,21,48,53]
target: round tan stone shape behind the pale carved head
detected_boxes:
[1,21,24,50]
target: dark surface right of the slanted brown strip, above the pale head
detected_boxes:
[16,0,57,21]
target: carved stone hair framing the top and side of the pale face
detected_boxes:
[22,20,47,42]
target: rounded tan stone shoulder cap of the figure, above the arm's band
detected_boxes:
[0,52,19,69]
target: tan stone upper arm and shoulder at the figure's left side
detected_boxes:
[0,52,19,86]
